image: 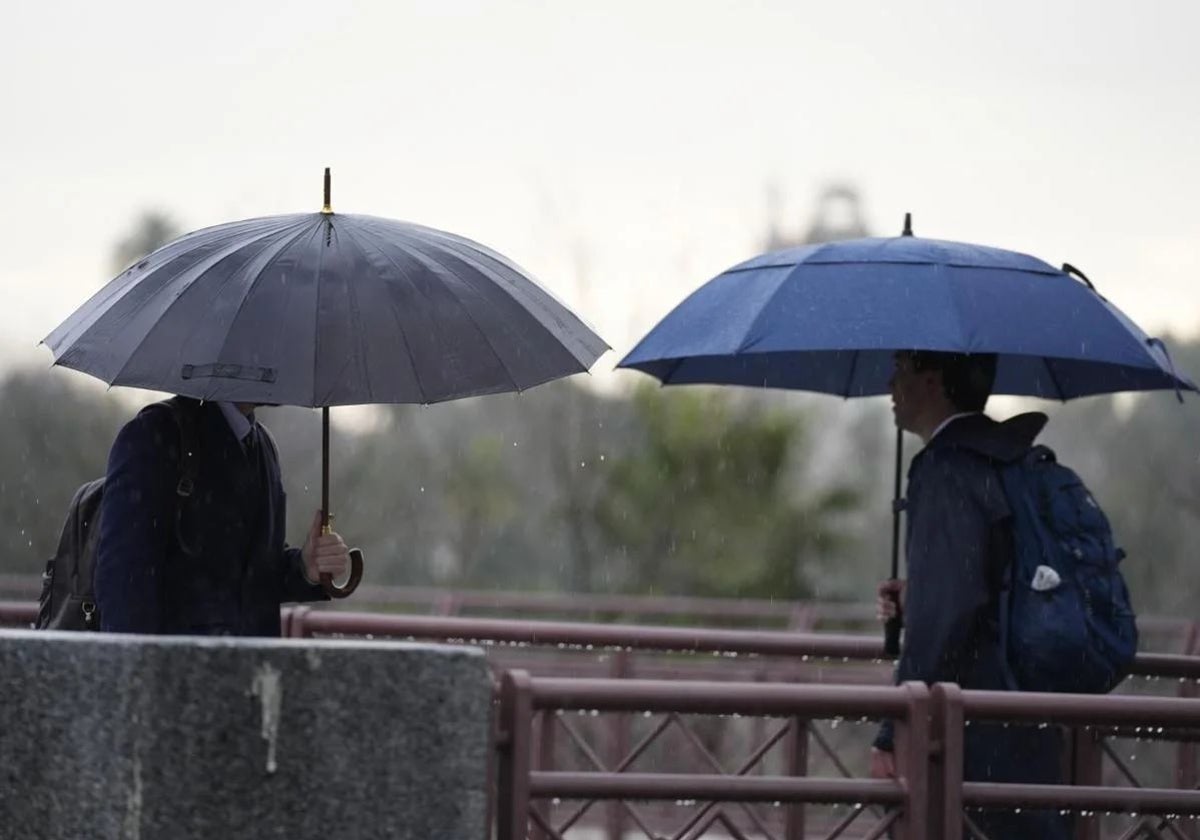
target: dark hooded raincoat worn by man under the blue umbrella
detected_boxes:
[875,414,1067,840]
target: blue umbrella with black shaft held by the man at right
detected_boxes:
[618,216,1196,653]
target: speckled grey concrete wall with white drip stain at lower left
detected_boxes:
[0,630,491,840]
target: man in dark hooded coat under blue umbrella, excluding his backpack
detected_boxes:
[871,352,1069,840]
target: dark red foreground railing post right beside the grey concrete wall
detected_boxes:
[496,671,533,840]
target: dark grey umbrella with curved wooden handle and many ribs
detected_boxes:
[43,169,607,596]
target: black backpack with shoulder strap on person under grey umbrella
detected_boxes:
[34,398,197,630]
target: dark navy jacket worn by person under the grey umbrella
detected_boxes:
[94,397,325,636]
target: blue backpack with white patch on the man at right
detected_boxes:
[1000,445,1138,694]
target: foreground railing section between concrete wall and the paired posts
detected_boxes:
[496,671,930,840]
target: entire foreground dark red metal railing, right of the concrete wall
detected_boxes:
[497,671,1200,840]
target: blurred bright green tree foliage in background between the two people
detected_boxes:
[596,386,858,598]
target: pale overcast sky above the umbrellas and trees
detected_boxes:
[0,0,1200,377]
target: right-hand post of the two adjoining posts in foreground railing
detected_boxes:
[929,683,964,840]
